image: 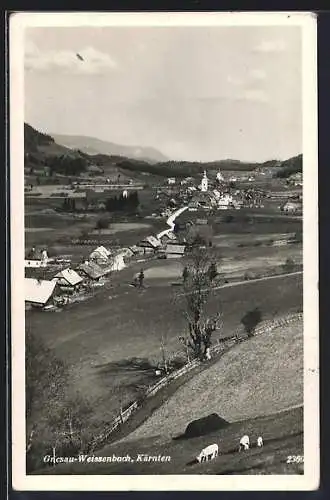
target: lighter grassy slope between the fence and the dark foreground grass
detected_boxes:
[122,323,303,440]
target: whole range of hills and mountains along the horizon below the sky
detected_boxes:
[24,123,302,180]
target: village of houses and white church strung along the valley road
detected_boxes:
[25,171,302,311]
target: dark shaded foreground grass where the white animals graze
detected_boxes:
[38,408,303,475]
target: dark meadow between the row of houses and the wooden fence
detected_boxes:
[26,269,302,421]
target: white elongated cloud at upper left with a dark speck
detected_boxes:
[25,42,117,75]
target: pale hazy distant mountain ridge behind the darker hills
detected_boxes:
[52,134,167,163]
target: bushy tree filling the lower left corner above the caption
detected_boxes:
[25,330,91,471]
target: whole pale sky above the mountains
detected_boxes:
[24,26,302,161]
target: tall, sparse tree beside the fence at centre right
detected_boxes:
[178,246,221,358]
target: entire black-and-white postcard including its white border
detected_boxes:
[9,12,319,491]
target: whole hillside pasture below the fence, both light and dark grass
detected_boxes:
[34,316,303,475]
